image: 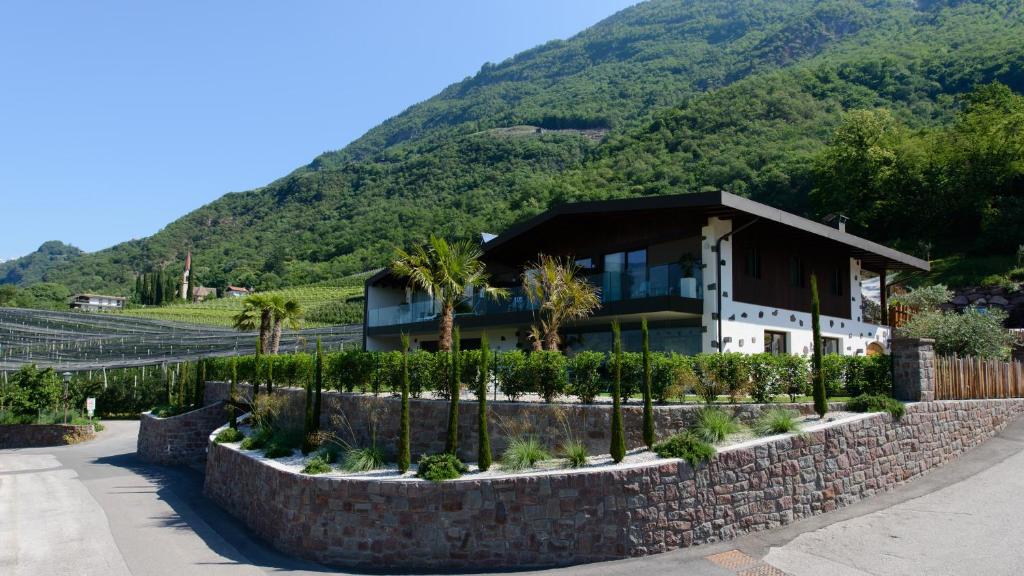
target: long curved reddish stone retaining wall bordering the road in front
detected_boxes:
[205,400,1024,570]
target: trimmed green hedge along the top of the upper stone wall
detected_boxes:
[206,351,892,404]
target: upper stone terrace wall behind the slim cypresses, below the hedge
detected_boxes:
[206,382,844,460]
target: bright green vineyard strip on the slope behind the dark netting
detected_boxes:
[118,283,362,328]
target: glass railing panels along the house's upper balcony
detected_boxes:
[367,264,703,327]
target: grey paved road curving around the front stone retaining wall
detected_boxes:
[6,419,1024,576]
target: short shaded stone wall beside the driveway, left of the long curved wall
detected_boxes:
[136,402,227,465]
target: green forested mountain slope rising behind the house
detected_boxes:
[0,0,1024,293]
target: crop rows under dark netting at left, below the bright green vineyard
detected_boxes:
[0,305,362,372]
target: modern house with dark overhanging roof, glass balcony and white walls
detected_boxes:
[364,192,929,355]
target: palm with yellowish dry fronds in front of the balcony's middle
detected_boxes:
[522,254,601,351]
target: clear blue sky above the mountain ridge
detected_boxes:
[0,0,636,259]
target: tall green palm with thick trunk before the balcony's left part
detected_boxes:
[391,235,508,352]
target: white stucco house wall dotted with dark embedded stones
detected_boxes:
[701,217,890,355]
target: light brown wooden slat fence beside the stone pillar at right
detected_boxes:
[935,356,1024,400]
